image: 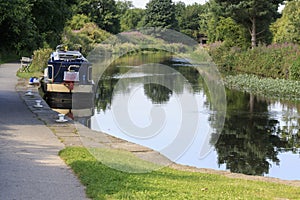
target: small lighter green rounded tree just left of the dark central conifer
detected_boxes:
[120,8,145,31]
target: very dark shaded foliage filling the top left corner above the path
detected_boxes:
[0,0,70,56]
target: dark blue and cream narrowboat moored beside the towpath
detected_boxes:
[40,45,94,109]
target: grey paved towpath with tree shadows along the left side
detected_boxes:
[0,63,86,200]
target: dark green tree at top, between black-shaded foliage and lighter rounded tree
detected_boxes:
[76,0,120,33]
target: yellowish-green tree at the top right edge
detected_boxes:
[271,0,300,44]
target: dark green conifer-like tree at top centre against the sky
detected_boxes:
[145,0,177,29]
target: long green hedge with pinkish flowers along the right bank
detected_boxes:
[210,43,300,80]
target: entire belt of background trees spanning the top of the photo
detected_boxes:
[0,0,300,55]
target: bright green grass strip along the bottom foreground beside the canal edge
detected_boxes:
[60,147,300,200]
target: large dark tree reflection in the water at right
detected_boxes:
[215,90,287,175]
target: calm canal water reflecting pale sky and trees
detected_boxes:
[85,54,300,180]
